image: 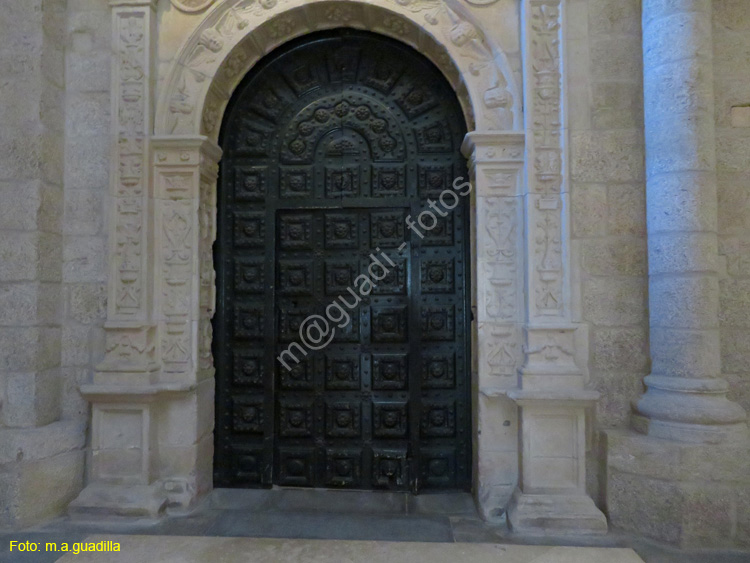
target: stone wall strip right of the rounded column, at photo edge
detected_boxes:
[713,0,750,410]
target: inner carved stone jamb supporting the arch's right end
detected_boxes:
[463,132,524,517]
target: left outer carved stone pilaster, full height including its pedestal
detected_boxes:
[68,0,168,517]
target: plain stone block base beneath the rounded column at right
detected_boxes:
[605,430,750,548]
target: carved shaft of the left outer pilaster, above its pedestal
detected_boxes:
[95,0,158,385]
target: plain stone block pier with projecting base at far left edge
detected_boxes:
[0,0,85,528]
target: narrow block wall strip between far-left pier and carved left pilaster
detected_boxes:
[61,0,111,420]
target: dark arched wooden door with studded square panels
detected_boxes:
[214,30,471,491]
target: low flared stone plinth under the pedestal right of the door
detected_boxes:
[508,490,607,536]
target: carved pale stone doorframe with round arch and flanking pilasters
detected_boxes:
[70,0,606,531]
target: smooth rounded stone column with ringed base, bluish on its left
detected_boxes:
[633,0,747,442]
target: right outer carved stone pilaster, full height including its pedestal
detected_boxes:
[508,0,607,534]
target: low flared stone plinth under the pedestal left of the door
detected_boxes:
[68,483,168,520]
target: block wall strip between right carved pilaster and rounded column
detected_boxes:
[567,0,649,432]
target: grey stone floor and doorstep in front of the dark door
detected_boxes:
[0,489,750,563]
